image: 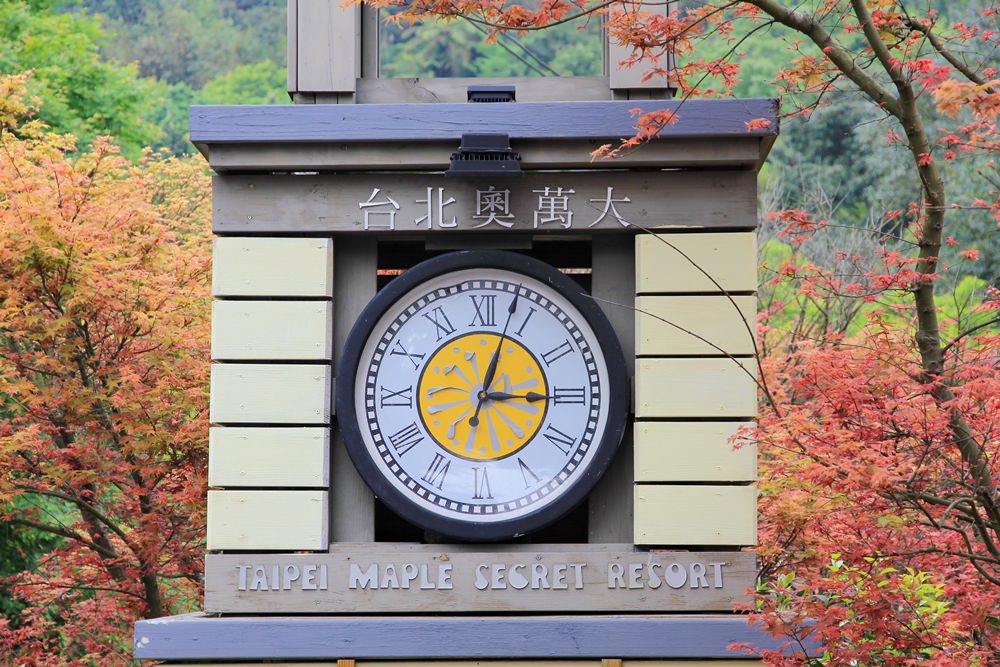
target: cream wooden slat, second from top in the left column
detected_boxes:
[212,301,333,361]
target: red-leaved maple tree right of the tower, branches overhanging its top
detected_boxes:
[366,0,1000,665]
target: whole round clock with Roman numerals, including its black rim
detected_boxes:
[337,251,627,540]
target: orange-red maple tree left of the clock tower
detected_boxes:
[0,76,210,665]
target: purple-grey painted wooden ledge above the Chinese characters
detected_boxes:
[191,98,778,144]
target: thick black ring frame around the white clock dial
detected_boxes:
[336,250,630,542]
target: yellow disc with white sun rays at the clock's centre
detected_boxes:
[417,333,548,461]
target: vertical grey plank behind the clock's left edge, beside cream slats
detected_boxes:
[330,237,378,542]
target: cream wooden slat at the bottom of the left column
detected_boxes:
[207,491,329,551]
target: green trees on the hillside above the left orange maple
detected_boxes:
[0,0,288,158]
